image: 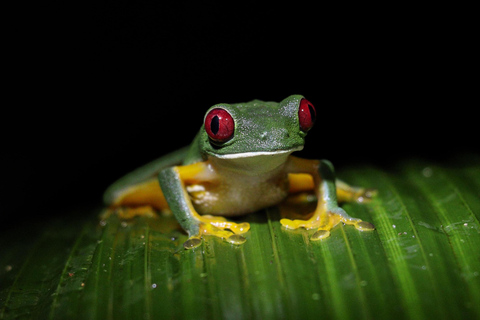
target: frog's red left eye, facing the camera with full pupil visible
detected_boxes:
[205,108,235,142]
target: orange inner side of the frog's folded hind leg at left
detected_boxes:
[100,177,168,220]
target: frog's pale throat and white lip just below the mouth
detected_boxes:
[208,146,303,175]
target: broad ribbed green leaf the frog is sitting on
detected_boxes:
[0,157,480,319]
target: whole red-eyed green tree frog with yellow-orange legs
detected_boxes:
[104,95,374,249]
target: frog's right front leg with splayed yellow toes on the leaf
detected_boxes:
[280,157,375,240]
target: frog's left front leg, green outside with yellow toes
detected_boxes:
[159,162,250,249]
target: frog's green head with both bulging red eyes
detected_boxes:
[200,95,316,159]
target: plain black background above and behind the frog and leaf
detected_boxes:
[0,0,478,227]
